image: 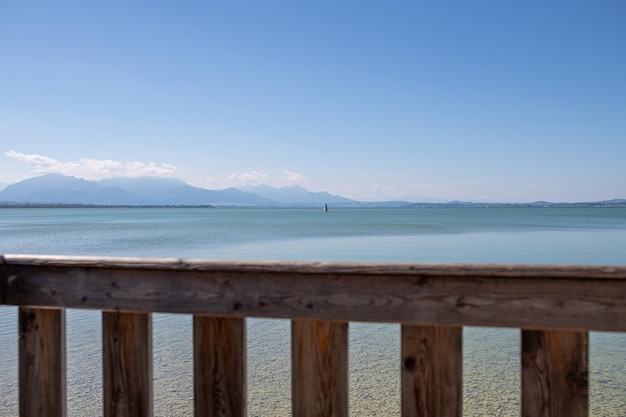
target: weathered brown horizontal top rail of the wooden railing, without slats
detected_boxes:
[2,255,626,331]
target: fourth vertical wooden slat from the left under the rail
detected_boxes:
[291,320,348,417]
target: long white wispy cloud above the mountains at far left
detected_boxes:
[5,150,179,180]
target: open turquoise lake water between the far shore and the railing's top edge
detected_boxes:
[0,208,626,263]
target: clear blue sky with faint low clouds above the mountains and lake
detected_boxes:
[0,0,626,202]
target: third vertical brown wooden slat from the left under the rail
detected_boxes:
[193,315,247,417]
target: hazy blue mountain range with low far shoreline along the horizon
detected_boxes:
[0,174,626,208]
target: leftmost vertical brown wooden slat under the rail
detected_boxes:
[19,307,66,417]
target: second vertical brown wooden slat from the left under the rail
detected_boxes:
[102,312,152,417]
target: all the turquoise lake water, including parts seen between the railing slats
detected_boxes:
[0,207,626,417]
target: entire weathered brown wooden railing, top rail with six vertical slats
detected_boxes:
[0,255,626,417]
